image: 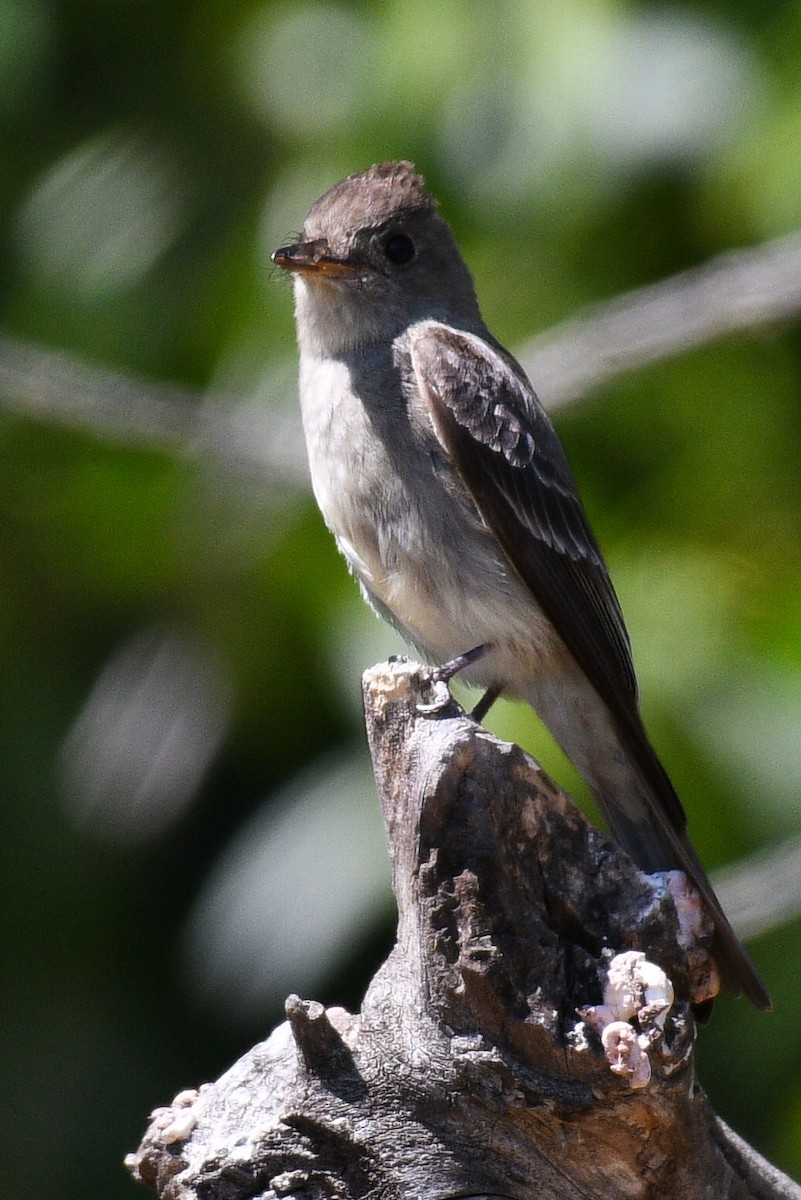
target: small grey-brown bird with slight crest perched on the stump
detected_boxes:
[272,161,771,1009]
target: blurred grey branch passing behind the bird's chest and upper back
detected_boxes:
[0,233,801,468]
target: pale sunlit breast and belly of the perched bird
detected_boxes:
[301,350,564,694]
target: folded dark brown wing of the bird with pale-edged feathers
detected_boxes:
[410,322,686,830]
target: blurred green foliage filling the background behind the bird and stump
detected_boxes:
[0,0,801,1200]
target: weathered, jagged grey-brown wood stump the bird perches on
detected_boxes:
[128,660,801,1200]
